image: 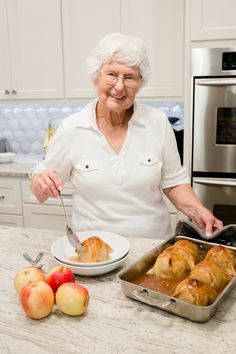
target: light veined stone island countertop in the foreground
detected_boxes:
[0,226,236,354]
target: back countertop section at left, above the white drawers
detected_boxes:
[0,162,35,177]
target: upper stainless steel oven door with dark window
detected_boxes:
[193,78,236,173]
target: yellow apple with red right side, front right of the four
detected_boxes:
[56,283,89,316]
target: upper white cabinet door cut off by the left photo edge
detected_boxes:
[0,0,11,99]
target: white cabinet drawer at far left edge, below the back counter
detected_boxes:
[0,177,22,214]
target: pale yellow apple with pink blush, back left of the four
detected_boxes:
[14,267,46,294]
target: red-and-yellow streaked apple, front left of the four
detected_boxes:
[20,280,54,320]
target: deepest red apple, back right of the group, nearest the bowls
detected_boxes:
[47,266,75,293]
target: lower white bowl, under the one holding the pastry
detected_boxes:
[53,253,128,277]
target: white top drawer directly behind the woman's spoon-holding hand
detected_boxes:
[21,179,73,206]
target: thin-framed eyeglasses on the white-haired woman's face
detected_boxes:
[99,71,142,88]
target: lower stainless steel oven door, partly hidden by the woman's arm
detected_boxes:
[193,177,236,225]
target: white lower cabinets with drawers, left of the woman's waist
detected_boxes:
[0,177,73,232]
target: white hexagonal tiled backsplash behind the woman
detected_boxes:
[0,101,184,162]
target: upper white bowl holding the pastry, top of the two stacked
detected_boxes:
[51,231,129,267]
